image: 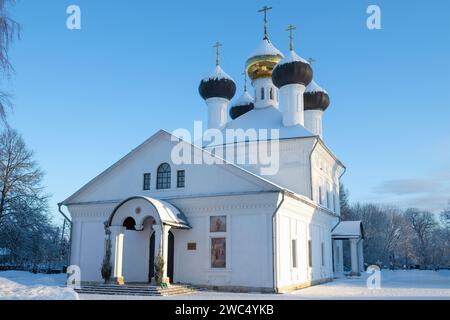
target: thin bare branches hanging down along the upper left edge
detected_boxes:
[0,0,20,123]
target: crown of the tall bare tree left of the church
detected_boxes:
[0,128,46,227]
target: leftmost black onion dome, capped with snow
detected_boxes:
[198,66,236,100]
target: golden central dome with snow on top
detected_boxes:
[246,38,283,81]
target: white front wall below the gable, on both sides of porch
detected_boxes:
[69,193,279,289]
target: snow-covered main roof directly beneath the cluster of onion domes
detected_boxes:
[223,107,315,142]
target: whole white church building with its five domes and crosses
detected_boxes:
[62,10,364,293]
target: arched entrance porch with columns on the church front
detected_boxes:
[104,196,191,285]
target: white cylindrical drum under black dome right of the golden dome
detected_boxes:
[280,83,306,127]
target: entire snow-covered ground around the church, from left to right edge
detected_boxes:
[0,270,450,300]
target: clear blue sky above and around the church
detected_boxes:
[1,0,450,224]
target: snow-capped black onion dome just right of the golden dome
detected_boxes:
[272,50,313,88]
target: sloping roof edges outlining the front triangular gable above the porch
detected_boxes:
[62,130,284,205]
